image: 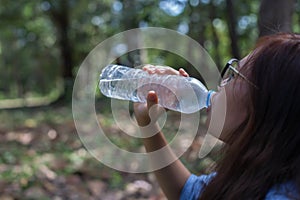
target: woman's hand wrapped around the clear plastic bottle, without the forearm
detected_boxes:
[134,65,189,126]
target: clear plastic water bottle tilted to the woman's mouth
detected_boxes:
[99,64,213,114]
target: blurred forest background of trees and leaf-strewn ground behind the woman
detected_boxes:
[0,0,300,199]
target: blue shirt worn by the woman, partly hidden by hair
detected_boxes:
[180,173,300,200]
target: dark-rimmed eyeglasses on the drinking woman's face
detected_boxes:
[219,58,258,88]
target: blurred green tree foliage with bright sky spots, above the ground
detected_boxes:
[0,0,300,99]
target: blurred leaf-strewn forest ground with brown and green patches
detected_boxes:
[0,106,214,200]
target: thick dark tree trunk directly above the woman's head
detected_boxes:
[258,0,296,37]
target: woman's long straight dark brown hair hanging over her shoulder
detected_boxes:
[200,33,300,200]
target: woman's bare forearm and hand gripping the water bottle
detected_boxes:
[134,65,191,199]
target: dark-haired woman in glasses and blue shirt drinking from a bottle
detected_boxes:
[135,34,300,200]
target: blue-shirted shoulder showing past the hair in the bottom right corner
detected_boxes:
[265,181,300,200]
